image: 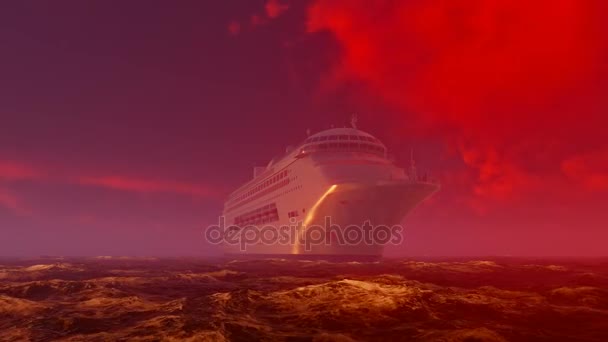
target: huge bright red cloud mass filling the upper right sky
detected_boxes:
[308,0,608,198]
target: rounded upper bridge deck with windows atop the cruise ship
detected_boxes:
[300,127,386,157]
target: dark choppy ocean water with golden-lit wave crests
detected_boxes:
[0,258,608,341]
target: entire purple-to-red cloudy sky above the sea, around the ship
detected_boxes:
[0,0,608,256]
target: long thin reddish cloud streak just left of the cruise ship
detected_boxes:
[79,176,217,197]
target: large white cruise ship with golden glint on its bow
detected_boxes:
[223,119,439,258]
